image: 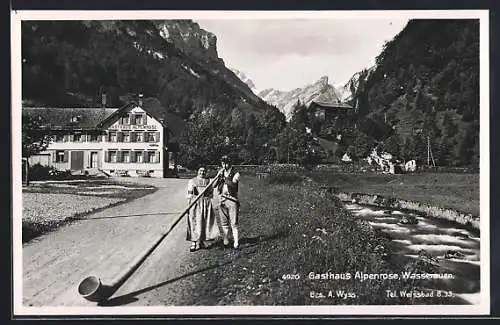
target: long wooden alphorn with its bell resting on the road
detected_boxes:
[78,171,222,303]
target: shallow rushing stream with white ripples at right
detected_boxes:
[344,202,480,304]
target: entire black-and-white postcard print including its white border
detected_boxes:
[11,10,490,316]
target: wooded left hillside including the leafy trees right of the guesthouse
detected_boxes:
[22,20,292,167]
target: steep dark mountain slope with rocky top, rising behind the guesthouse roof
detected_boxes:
[22,20,268,118]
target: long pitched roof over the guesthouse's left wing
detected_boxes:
[22,107,118,129]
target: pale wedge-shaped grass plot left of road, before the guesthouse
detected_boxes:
[22,180,157,243]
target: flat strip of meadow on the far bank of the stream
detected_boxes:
[308,172,480,216]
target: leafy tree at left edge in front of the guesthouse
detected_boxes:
[22,116,52,158]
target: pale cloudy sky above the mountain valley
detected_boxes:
[195,18,408,91]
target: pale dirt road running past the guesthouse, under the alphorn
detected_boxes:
[22,179,217,306]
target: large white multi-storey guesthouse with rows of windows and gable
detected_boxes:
[23,102,172,177]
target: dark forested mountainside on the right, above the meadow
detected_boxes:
[344,19,479,166]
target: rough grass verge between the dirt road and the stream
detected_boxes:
[182,175,466,305]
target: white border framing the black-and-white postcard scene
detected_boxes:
[11,10,490,316]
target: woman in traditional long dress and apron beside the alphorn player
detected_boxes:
[186,167,219,252]
